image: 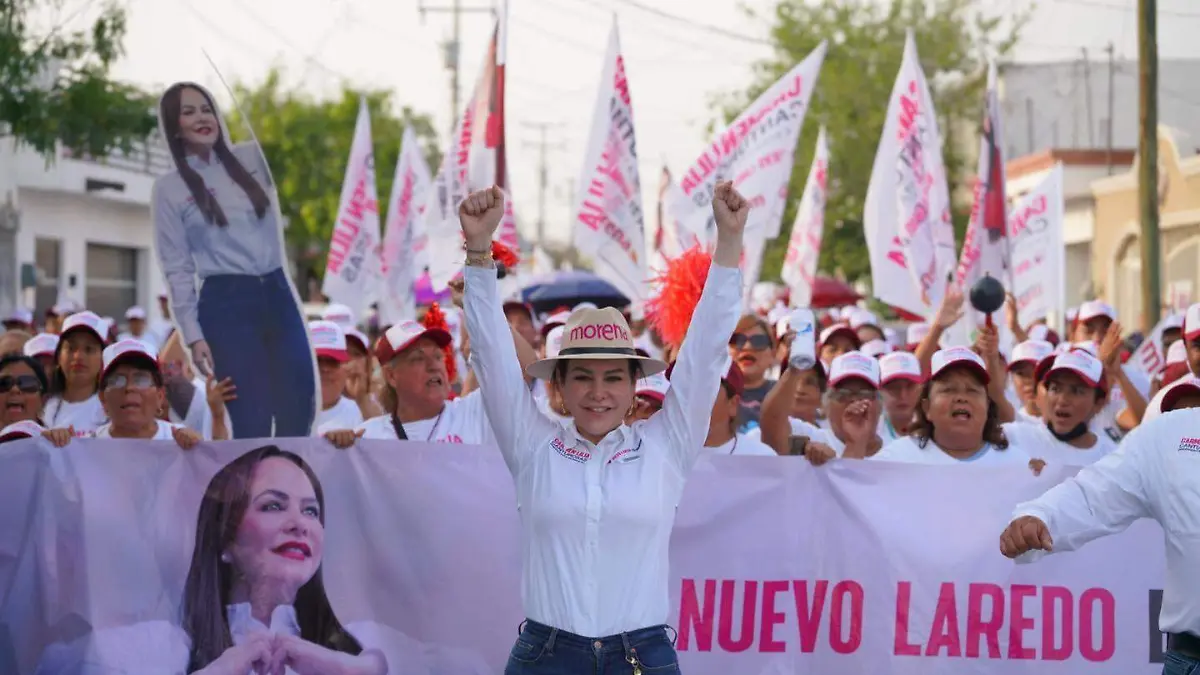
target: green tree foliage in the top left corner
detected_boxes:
[0,0,156,159]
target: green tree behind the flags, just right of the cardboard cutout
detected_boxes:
[229,70,440,285]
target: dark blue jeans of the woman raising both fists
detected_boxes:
[504,621,679,675]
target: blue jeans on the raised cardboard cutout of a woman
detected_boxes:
[197,269,317,438]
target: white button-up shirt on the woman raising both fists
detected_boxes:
[463,264,742,637]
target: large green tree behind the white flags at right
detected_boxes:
[720,0,1024,296]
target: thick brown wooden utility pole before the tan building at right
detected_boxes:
[1138,0,1163,335]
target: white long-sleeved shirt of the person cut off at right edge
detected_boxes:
[1013,410,1200,635]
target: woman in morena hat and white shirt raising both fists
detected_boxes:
[458,183,749,675]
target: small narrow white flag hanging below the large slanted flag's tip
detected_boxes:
[780,126,829,307]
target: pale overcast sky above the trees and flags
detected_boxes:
[32,0,1200,246]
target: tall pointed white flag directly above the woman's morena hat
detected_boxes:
[571,18,647,301]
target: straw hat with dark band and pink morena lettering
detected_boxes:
[526,307,667,380]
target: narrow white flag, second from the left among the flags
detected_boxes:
[379,125,433,324]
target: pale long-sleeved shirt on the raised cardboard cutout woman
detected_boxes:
[154,143,283,345]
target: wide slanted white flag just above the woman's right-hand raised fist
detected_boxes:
[667,42,826,249]
